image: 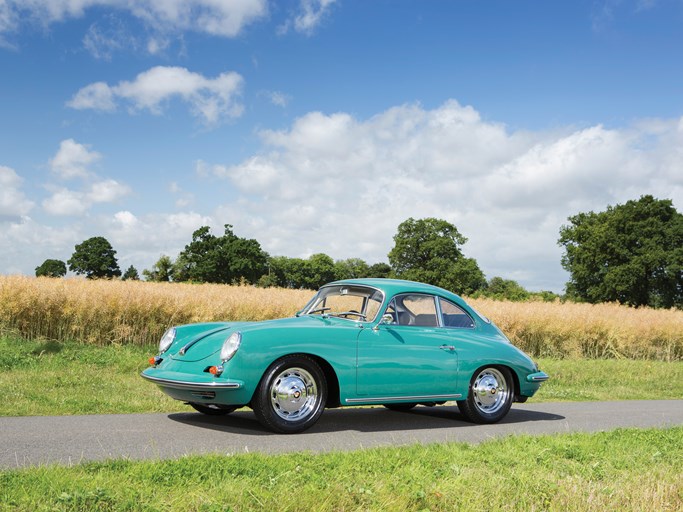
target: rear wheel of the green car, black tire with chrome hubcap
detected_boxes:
[457,366,515,423]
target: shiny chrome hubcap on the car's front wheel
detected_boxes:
[270,368,318,421]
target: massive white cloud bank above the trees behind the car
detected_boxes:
[208,101,683,291]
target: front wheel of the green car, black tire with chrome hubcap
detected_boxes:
[252,355,327,434]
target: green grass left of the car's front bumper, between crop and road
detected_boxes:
[0,337,188,416]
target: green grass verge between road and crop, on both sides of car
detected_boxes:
[0,337,683,416]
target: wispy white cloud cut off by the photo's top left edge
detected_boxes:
[0,0,268,45]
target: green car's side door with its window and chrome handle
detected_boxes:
[356,293,459,401]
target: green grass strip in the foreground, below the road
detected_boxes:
[0,427,683,512]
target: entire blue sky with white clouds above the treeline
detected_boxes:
[0,0,683,292]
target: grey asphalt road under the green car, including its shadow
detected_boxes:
[0,400,683,469]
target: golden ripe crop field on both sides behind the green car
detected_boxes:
[0,276,683,361]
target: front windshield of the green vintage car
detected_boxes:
[300,285,384,322]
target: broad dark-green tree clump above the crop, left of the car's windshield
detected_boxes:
[175,224,267,283]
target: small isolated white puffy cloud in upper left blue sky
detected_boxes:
[67,66,244,125]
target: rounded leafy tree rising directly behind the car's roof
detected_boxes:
[389,218,486,294]
